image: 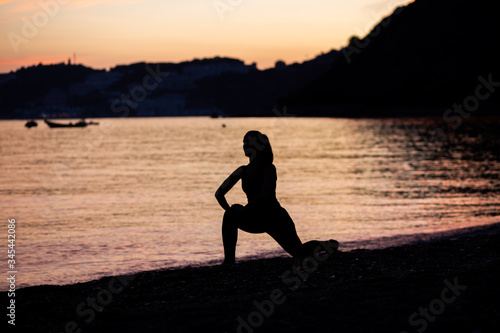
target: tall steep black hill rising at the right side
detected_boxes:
[282,0,500,115]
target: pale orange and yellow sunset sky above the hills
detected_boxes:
[0,0,411,73]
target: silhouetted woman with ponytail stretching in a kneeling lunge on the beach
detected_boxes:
[215,131,338,264]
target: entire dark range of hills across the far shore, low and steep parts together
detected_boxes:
[0,0,500,118]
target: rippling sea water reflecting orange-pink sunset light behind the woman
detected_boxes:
[0,118,500,290]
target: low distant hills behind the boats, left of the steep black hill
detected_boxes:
[0,51,338,119]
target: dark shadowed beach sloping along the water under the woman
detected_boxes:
[7,220,500,333]
